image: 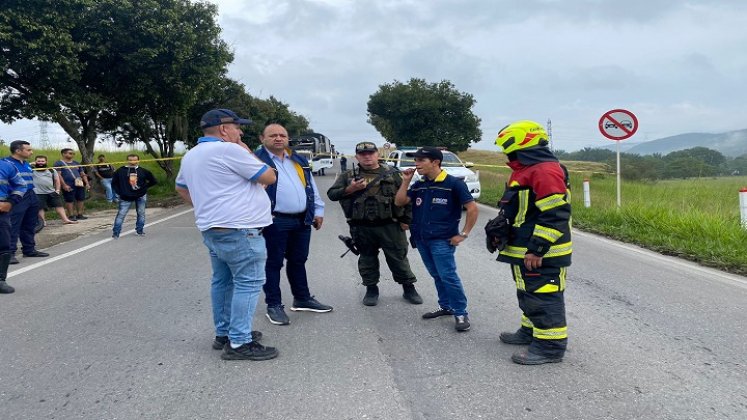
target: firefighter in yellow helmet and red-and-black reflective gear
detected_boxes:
[488,121,571,365]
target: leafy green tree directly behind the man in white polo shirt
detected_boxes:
[101,0,233,178]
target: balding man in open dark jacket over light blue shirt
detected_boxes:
[256,124,332,325]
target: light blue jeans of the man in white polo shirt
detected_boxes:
[202,229,267,345]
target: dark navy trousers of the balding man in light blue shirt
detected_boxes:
[262,216,311,306]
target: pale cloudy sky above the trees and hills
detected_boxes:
[0,0,747,152]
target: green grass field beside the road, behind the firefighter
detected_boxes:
[460,151,747,274]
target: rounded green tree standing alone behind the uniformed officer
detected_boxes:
[368,79,482,152]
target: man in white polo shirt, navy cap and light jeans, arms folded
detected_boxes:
[176,109,278,360]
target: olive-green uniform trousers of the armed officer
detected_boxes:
[350,223,415,286]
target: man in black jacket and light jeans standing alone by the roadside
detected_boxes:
[112,154,156,239]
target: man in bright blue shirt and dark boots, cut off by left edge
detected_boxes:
[0,159,26,294]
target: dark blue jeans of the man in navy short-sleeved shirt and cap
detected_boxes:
[415,239,467,315]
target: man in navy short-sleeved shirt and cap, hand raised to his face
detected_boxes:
[394,146,478,332]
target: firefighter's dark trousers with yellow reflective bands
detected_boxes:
[511,264,568,357]
